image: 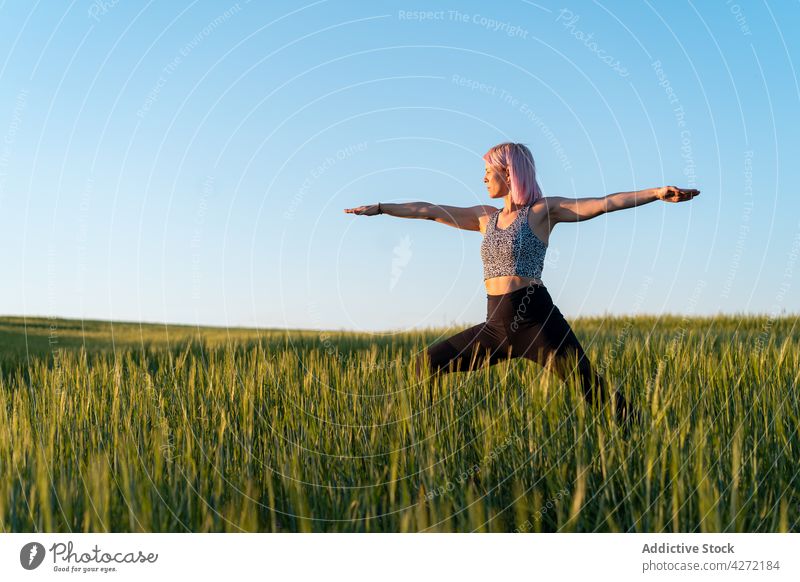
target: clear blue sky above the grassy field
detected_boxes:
[0,0,800,331]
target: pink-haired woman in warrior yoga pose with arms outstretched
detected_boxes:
[345,143,700,420]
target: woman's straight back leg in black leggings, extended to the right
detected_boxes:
[508,287,628,420]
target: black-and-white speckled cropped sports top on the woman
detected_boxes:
[481,206,547,281]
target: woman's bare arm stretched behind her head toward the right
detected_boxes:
[544,186,700,223]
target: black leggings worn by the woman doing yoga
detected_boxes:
[417,284,627,419]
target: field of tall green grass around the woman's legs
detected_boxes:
[0,317,800,532]
